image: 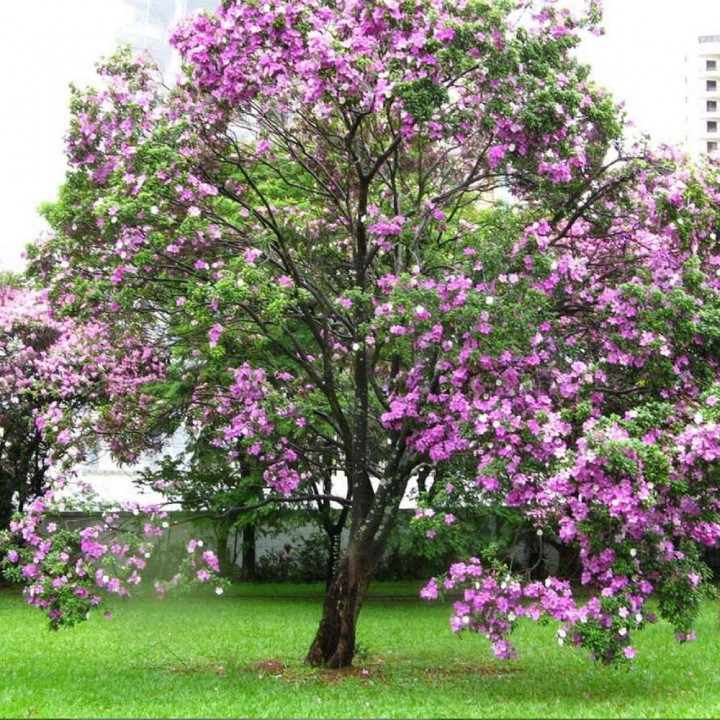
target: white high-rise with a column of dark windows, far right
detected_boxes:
[685,35,720,155]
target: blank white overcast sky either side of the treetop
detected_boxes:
[0,0,720,276]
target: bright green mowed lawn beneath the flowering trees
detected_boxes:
[0,584,720,718]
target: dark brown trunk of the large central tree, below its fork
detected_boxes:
[305,547,374,668]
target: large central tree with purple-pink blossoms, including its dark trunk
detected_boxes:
[15,0,720,667]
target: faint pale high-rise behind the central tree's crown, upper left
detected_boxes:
[117,0,215,77]
